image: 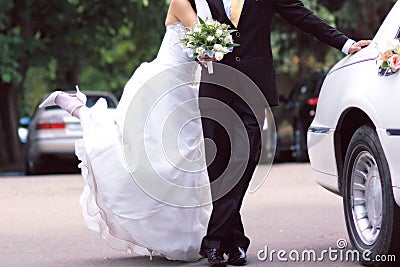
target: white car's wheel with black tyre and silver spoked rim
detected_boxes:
[343,125,400,265]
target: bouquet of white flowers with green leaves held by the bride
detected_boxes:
[182,18,239,73]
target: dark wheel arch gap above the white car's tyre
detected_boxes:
[334,108,375,195]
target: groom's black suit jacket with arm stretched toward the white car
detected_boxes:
[200,0,348,106]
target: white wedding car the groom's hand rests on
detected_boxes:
[307,1,400,265]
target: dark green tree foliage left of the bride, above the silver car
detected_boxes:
[0,0,168,114]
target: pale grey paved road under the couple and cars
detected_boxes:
[0,163,358,267]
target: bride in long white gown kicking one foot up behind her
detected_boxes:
[40,0,211,261]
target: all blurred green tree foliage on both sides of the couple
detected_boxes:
[0,0,396,114]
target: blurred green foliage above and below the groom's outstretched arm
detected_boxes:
[271,0,396,77]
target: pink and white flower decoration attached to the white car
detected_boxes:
[377,39,400,76]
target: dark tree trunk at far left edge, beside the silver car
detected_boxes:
[0,82,23,171]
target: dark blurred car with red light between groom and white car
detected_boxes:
[261,72,326,162]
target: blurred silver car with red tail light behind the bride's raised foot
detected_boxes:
[25,91,118,174]
